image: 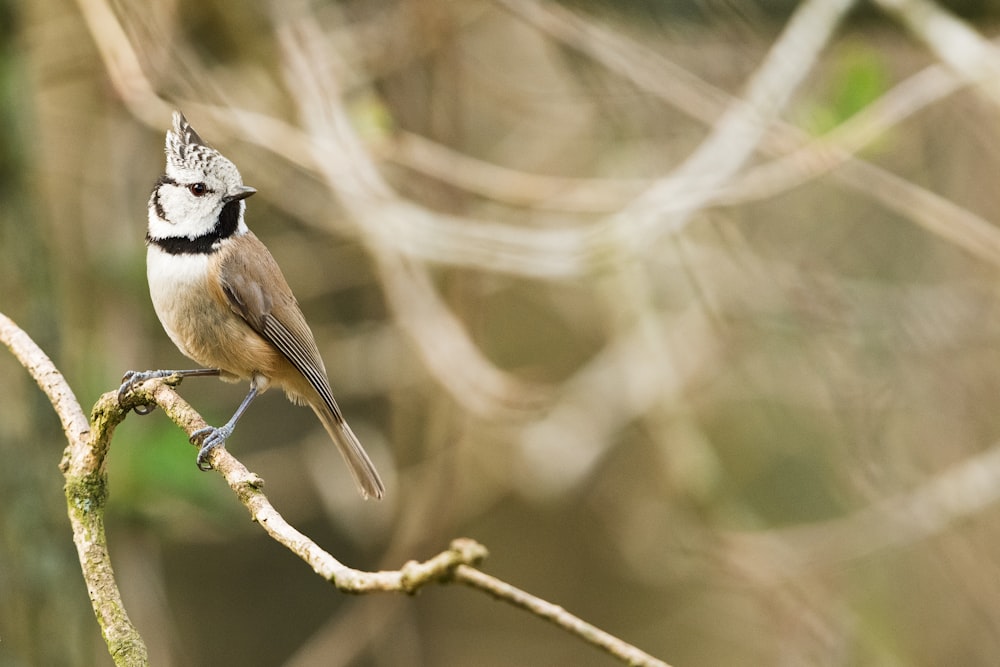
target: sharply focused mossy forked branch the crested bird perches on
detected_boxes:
[0,313,669,667]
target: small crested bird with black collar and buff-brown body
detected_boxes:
[118,111,385,498]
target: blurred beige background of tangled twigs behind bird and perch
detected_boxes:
[0,0,1000,667]
